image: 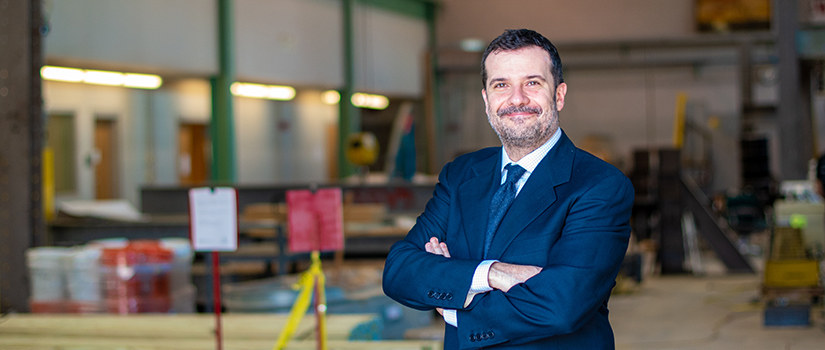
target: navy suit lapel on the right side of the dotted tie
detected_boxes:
[488,133,576,259]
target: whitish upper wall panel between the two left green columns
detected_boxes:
[235,0,344,88]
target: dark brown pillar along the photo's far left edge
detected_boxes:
[0,0,45,313]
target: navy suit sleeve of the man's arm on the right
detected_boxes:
[458,175,634,348]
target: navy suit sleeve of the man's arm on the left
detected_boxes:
[383,163,481,310]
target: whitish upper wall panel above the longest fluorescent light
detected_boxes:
[44,0,217,75]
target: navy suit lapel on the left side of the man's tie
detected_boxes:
[458,151,501,258]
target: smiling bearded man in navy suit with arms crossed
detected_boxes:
[383,29,633,349]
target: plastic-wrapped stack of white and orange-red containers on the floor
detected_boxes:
[27,238,195,314]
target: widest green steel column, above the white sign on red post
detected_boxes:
[209,0,236,184]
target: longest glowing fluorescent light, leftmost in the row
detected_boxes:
[40,66,163,89]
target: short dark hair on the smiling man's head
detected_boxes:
[481,29,564,89]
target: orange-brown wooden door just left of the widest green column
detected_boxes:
[178,123,212,185]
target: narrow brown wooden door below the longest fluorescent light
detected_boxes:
[92,119,118,199]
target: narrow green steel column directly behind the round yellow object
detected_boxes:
[338,0,361,179]
